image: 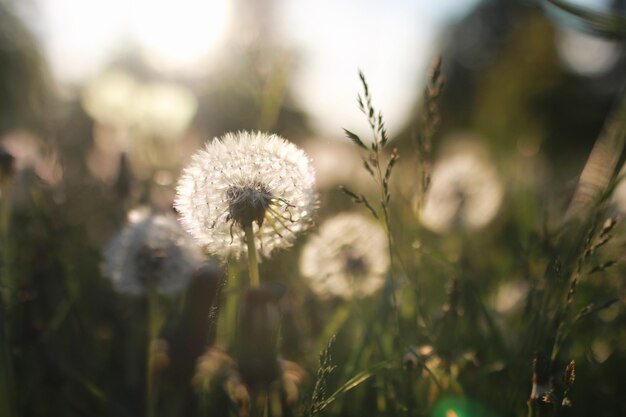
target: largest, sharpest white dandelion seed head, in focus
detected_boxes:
[174,132,317,256]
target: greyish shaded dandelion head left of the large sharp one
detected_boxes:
[104,211,202,295]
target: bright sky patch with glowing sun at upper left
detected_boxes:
[18,0,229,79]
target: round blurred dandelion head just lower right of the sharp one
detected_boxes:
[300,213,389,298]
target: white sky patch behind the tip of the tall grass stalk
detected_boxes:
[280,0,477,136]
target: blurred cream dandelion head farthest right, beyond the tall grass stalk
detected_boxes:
[420,146,503,233]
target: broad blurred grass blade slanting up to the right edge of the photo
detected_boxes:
[528,94,626,417]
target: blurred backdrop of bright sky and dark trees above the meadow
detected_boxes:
[0,0,624,197]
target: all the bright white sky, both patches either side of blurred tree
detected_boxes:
[18,0,477,136]
